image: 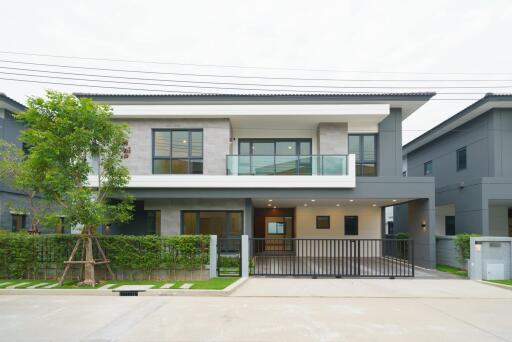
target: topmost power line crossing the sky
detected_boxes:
[0,50,512,75]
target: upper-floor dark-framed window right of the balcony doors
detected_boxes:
[348,134,377,176]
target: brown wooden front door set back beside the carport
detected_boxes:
[265,216,293,252]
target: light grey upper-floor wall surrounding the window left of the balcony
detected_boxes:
[116,119,231,175]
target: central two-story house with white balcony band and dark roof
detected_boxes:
[77,93,435,267]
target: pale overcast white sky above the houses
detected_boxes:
[0,0,512,143]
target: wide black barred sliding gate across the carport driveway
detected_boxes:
[249,238,414,278]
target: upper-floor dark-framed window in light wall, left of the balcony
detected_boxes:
[153,129,203,174]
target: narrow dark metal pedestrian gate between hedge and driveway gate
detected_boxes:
[217,237,242,277]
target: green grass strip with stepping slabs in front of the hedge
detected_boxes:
[0,277,239,290]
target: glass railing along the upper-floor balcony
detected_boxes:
[226,155,348,176]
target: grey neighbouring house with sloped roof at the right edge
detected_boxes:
[399,94,512,236]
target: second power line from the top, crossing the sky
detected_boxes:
[0,60,512,82]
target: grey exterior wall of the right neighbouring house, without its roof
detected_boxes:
[407,108,512,235]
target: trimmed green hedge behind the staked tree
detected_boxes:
[0,233,209,278]
